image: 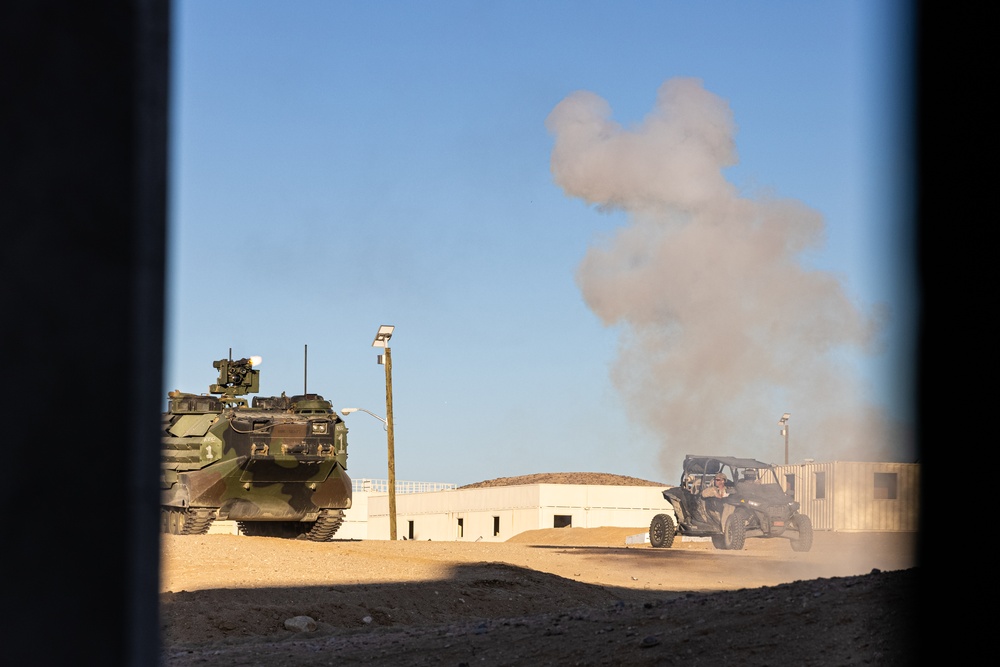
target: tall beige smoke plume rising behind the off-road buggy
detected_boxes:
[546,79,911,471]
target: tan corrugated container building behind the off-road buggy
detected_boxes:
[776,461,920,532]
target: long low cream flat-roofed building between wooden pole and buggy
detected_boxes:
[367,484,673,542]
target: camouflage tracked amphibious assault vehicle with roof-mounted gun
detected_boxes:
[160,355,351,542]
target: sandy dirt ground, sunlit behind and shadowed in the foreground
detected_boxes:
[161,527,920,667]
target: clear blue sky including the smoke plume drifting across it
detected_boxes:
[164,0,917,485]
